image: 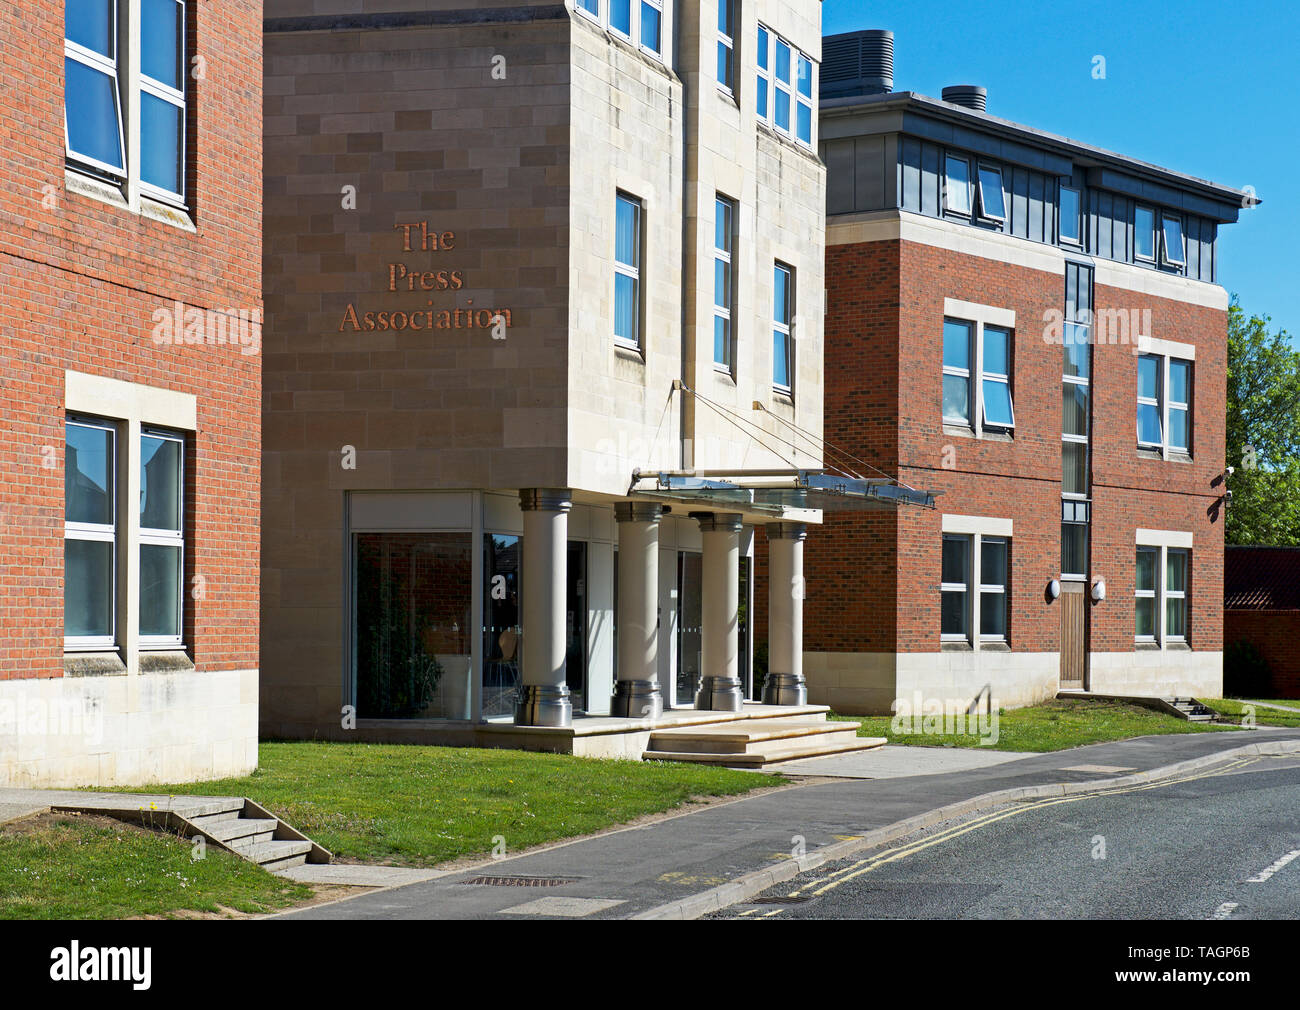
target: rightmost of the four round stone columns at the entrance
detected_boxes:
[763,523,809,705]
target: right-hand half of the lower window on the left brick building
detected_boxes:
[138,429,185,649]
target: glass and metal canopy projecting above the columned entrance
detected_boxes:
[628,469,936,519]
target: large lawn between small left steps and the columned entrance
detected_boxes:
[116,742,784,866]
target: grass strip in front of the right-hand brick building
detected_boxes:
[832,699,1237,751]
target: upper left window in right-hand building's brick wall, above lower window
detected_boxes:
[943,298,1015,435]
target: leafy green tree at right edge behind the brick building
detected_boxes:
[1225,295,1300,546]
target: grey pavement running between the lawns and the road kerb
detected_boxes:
[274,728,1300,919]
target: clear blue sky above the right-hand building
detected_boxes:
[822,0,1300,346]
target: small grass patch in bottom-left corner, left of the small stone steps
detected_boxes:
[0,814,313,919]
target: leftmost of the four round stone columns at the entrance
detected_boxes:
[515,487,573,727]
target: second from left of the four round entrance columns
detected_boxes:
[610,502,663,719]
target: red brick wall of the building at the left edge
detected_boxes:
[0,0,261,679]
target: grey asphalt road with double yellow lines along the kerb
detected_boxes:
[710,757,1300,922]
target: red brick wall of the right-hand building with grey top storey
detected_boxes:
[805,242,1226,662]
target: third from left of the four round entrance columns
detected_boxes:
[693,512,745,712]
